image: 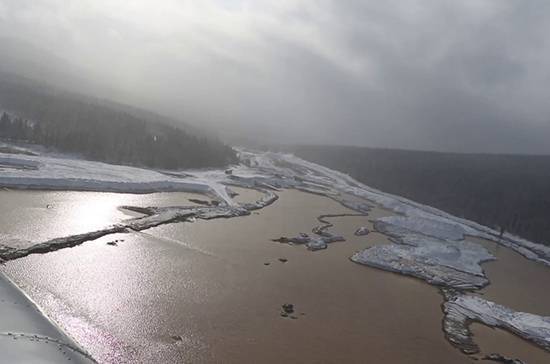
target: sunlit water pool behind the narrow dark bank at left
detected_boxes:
[0,191,210,243]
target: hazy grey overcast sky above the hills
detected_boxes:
[0,0,550,153]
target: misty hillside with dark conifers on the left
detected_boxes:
[0,78,236,169]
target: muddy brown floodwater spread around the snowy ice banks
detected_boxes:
[0,189,550,363]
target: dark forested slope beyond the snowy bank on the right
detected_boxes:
[292,146,550,245]
